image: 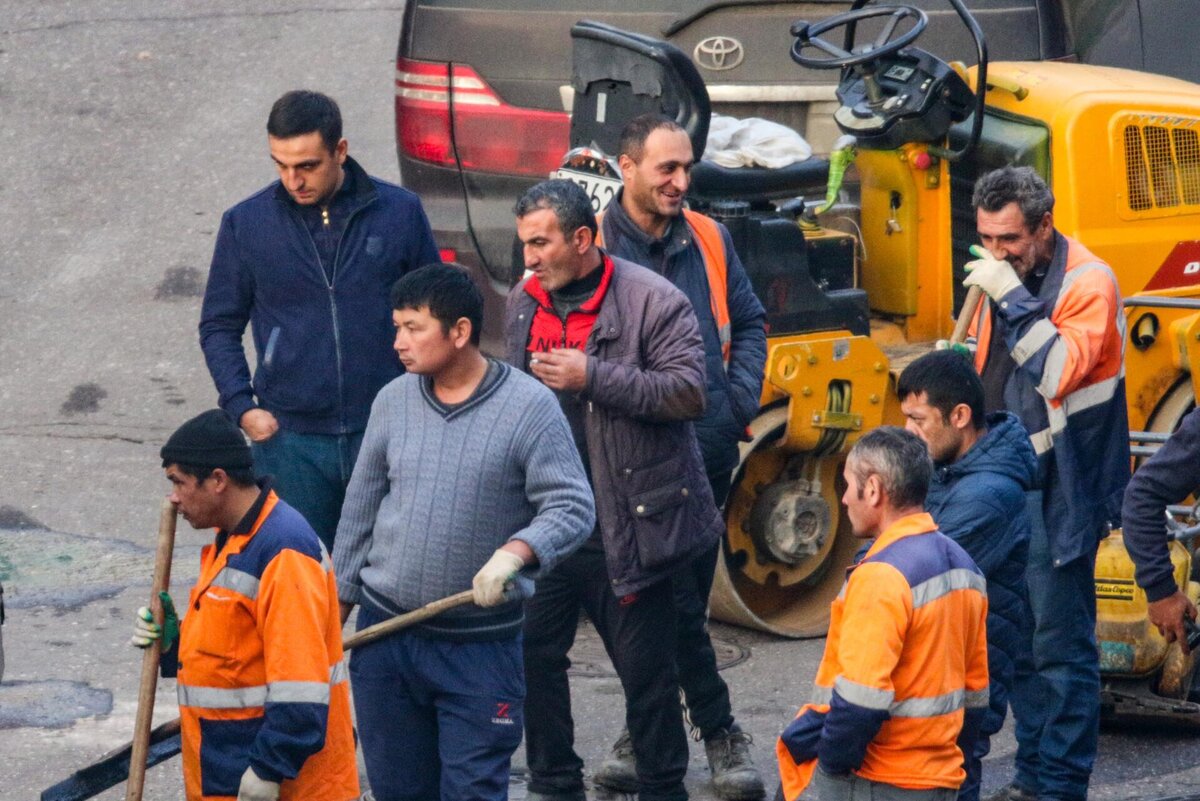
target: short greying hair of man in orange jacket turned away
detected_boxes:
[846,426,934,508]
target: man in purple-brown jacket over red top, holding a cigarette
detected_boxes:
[505,181,725,801]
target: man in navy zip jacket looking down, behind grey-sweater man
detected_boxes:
[200,90,440,550]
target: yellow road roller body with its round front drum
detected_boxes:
[712,62,1200,637]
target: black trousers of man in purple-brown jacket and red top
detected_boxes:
[524,541,688,801]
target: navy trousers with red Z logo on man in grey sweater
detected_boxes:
[350,606,524,801]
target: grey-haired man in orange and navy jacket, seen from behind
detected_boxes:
[775,426,988,801]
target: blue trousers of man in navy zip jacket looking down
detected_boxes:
[251,428,362,553]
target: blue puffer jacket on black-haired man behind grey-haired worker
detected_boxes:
[925,411,1042,736]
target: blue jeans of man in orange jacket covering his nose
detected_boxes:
[1010,524,1100,801]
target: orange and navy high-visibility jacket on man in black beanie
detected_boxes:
[176,490,359,801]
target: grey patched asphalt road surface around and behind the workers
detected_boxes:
[7,0,1200,801]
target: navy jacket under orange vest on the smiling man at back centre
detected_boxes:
[600,189,767,476]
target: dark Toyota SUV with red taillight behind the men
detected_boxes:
[396,0,1158,353]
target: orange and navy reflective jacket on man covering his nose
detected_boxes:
[970,231,1129,565]
